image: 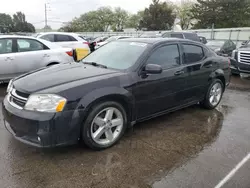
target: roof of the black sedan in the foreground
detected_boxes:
[121,38,198,44]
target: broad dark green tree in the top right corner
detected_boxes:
[191,0,250,28]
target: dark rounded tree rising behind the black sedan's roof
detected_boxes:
[140,0,176,30]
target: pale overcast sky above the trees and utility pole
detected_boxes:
[0,0,157,29]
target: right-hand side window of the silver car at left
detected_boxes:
[17,39,44,52]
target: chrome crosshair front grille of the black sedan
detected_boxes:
[8,89,29,109]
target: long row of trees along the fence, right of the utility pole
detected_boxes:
[60,0,250,32]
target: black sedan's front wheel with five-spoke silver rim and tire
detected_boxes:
[81,101,127,150]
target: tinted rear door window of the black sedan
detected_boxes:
[183,44,204,64]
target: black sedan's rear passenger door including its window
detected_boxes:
[182,43,214,101]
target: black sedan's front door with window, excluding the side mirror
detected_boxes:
[133,43,187,119]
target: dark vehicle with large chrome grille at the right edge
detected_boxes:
[231,42,250,75]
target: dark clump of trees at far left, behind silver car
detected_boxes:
[0,12,36,33]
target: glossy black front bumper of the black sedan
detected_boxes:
[2,98,83,148]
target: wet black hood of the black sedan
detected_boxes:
[13,63,118,93]
